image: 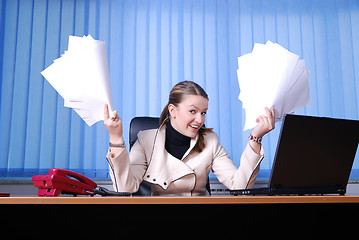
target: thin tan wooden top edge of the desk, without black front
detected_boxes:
[0,195,359,204]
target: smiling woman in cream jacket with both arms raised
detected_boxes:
[104,81,274,196]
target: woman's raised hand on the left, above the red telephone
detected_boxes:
[103,104,124,144]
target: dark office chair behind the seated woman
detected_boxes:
[130,117,211,196]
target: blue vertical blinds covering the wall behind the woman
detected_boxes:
[0,0,359,180]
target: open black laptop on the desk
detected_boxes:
[230,114,359,195]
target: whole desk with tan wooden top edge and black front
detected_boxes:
[0,195,359,234]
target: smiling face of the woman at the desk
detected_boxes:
[168,95,208,138]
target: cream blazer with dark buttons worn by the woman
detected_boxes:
[107,125,264,196]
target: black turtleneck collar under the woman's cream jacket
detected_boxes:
[165,122,191,159]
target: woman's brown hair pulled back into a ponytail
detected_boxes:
[160,81,212,152]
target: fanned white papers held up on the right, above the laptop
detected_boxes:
[237,41,310,130]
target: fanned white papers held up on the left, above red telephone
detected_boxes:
[41,35,113,126]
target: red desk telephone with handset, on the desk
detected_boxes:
[32,168,97,196]
